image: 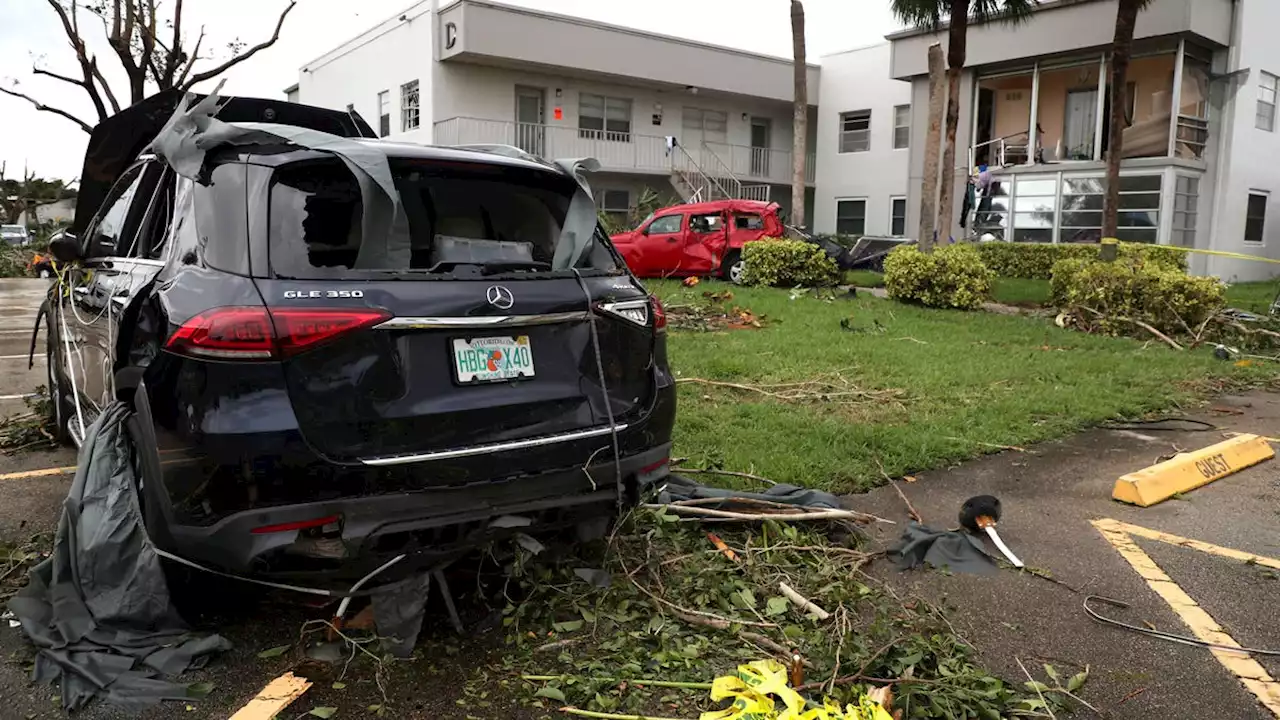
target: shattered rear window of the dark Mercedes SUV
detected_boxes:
[269,159,614,278]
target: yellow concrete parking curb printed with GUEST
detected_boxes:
[1111,434,1276,507]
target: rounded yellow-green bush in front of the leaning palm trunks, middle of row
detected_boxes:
[884,243,995,310]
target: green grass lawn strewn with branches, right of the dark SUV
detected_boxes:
[650,282,1262,491]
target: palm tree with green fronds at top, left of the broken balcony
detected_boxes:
[890,0,1039,245]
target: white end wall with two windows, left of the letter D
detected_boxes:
[296,3,434,142]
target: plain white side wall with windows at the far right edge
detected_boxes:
[1199,0,1280,282]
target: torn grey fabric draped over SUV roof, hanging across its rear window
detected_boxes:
[148,83,409,270]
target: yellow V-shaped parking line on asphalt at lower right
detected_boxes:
[1093,518,1280,717]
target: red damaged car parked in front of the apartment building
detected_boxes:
[609,200,786,282]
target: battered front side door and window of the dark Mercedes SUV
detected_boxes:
[59,160,163,437]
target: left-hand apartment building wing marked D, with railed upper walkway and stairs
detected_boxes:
[285,0,819,221]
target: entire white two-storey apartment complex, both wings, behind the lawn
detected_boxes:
[287,0,1280,281]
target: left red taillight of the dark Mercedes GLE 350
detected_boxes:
[165,307,390,360]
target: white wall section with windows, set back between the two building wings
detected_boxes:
[810,42,923,237]
